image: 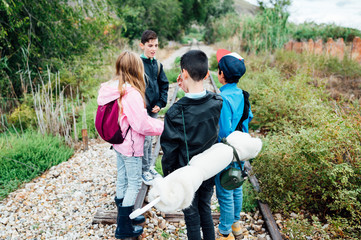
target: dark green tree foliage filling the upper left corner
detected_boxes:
[0,0,121,101]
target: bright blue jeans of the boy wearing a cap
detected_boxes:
[215,162,243,235]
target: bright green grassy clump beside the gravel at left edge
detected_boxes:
[0,131,73,199]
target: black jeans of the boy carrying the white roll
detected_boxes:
[183,178,215,240]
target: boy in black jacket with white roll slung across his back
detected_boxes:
[160,50,222,240]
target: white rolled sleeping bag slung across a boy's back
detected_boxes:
[131,131,262,218]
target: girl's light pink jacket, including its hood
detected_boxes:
[98,80,164,157]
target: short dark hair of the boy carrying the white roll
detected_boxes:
[180,50,208,82]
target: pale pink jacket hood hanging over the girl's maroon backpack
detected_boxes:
[97,80,132,106]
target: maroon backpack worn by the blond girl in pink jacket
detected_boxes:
[95,99,130,144]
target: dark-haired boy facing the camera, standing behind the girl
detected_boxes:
[140,30,169,185]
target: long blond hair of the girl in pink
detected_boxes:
[115,51,145,103]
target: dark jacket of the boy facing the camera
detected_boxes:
[141,57,169,114]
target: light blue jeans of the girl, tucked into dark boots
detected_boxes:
[115,151,142,207]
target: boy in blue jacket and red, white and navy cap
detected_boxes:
[215,49,253,240]
